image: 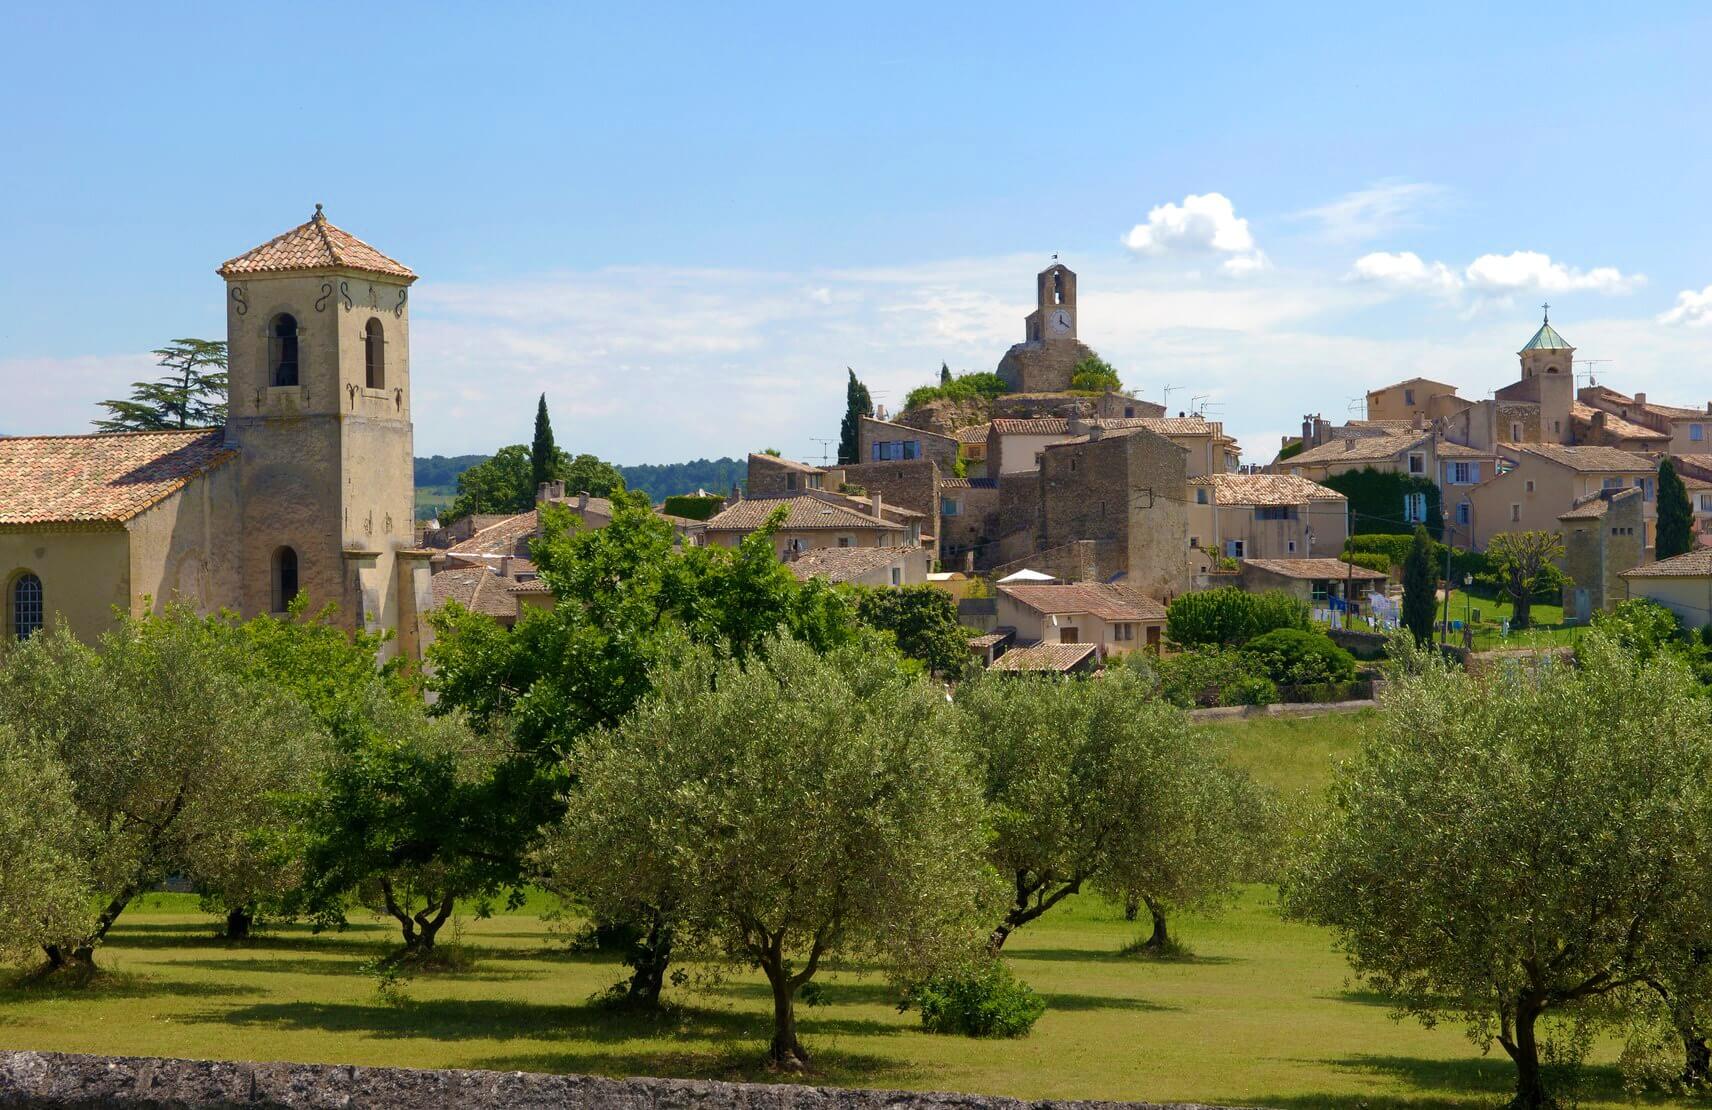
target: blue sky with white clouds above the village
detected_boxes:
[0,3,1712,464]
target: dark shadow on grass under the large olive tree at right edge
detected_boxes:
[1246,1052,1674,1110]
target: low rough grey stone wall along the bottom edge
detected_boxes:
[0,1052,1239,1110]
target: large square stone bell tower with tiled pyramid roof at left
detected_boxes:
[217,204,426,654]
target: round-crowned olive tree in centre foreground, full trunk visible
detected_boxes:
[539,639,993,1071]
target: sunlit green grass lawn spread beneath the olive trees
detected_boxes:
[0,714,1684,1110]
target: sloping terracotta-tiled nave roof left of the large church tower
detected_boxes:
[0,428,238,526]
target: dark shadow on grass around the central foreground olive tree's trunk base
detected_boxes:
[469,1048,919,1086]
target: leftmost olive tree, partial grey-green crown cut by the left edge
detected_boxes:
[0,725,94,959]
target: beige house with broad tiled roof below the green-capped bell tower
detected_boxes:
[1445,444,1657,548]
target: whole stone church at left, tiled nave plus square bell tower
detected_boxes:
[0,204,431,658]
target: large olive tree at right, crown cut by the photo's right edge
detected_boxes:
[1284,630,1712,1107]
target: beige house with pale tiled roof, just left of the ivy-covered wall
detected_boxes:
[1188,474,1349,569]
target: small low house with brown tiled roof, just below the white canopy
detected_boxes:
[996,582,1166,656]
